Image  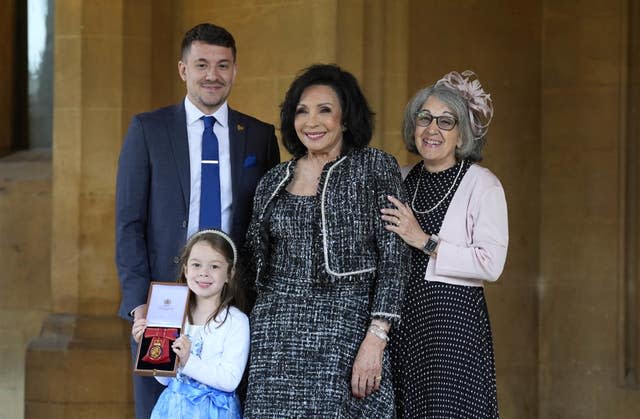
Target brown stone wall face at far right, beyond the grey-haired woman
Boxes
[539,0,640,419]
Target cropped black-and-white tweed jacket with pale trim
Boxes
[244,147,410,322]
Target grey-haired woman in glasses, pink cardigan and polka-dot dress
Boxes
[382,71,508,418]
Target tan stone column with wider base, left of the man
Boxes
[25,0,169,419]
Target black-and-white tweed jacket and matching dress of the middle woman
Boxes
[244,148,409,418]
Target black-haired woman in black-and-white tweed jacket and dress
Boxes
[245,65,408,418]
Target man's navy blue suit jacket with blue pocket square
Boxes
[116,103,280,319]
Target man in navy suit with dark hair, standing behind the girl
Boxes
[116,23,280,419]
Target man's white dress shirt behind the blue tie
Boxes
[184,97,233,238]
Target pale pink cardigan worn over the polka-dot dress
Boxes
[425,164,509,287]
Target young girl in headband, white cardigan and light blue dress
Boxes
[133,230,249,419]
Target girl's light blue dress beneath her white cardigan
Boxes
[151,325,242,419]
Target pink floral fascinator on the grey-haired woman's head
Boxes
[435,70,493,140]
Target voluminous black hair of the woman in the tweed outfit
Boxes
[280,64,374,157]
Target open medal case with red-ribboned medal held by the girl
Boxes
[133,281,189,377]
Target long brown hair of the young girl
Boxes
[177,230,245,327]
